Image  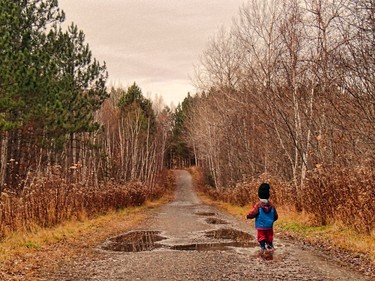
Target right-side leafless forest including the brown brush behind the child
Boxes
[181,0,375,233]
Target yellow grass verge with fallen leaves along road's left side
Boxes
[0,187,173,280]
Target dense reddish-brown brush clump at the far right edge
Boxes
[302,167,375,233]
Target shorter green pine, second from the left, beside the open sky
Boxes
[49,23,108,134]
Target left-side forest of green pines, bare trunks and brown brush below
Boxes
[0,0,172,237]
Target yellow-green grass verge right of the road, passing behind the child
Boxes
[198,192,375,266]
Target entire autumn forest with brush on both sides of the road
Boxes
[0,0,375,241]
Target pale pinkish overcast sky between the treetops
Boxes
[59,0,244,105]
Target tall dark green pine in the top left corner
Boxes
[0,0,64,131]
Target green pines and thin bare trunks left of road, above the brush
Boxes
[0,0,172,192]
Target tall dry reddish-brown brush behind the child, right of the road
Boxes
[192,167,375,234]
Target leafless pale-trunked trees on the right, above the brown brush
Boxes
[189,0,374,188]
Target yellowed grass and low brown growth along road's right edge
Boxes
[190,166,375,266]
